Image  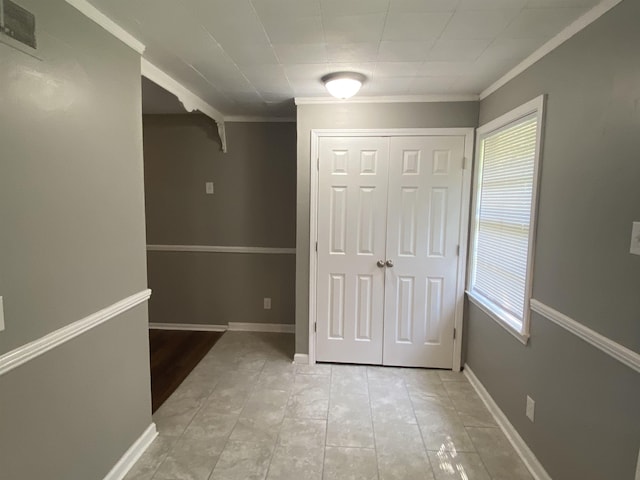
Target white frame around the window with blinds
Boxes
[466,95,546,345]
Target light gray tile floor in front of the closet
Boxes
[126,332,532,480]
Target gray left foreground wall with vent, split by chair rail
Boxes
[0,0,151,480]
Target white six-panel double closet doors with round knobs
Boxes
[316,136,465,368]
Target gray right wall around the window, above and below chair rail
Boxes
[466,0,640,480]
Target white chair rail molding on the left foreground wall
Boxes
[0,289,151,375]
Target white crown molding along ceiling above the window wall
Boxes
[480,0,622,100]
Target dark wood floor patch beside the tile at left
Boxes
[149,330,222,412]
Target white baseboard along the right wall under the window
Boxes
[463,365,551,480]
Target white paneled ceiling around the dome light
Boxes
[90,0,598,116]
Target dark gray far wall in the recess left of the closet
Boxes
[144,115,296,324]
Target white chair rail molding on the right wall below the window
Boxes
[529,298,640,372]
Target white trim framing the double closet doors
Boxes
[309,128,474,371]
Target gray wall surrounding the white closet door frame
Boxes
[296,102,478,353]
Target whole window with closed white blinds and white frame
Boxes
[467,96,544,343]
